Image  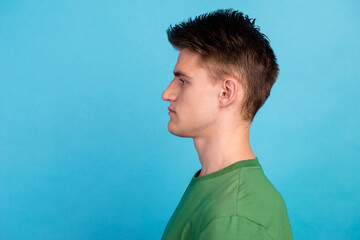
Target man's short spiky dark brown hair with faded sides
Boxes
[167,9,279,121]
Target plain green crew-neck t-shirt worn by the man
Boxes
[161,158,293,240]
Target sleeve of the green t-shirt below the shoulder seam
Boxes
[196,216,273,240]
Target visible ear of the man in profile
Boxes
[219,77,241,106]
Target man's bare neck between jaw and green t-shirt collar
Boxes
[193,120,256,176]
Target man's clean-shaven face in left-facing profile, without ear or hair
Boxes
[162,49,220,137]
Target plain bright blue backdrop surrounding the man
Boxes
[0,0,360,239]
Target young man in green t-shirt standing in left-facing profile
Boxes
[162,9,292,240]
